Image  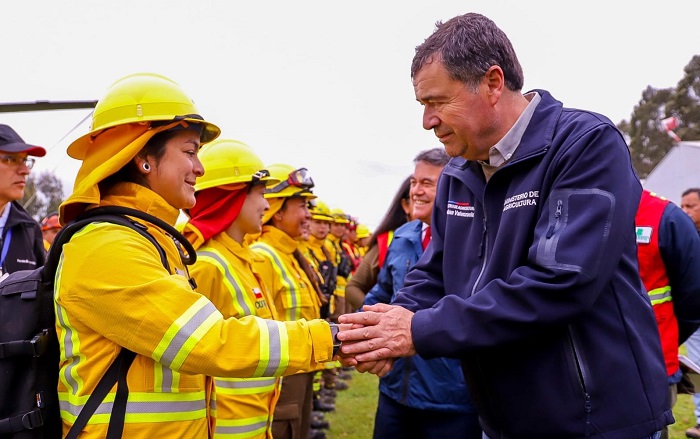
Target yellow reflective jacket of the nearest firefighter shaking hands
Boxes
[54,183,333,439]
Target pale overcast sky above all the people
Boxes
[0,0,700,227]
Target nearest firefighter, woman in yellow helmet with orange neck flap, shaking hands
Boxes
[54,74,334,438]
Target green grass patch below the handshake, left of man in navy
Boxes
[325,371,379,439]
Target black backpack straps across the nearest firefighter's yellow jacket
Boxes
[57,211,176,439]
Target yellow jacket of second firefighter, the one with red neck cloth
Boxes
[190,232,280,439]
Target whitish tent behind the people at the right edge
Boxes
[642,141,700,206]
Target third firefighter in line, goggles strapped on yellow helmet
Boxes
[251,164,327,439]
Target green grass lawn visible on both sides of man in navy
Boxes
[326,372,695,439]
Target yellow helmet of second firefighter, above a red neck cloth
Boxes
[194,138,279,191]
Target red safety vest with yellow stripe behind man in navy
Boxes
[634,190,679,376]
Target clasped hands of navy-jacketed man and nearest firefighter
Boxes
[338,303,416,376]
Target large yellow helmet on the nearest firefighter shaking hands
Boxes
[68,73,221,160]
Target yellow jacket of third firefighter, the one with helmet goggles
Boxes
[250,226,321,320]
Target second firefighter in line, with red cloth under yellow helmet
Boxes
[184,139,280,439]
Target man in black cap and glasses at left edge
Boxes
[0,125,46,274]
